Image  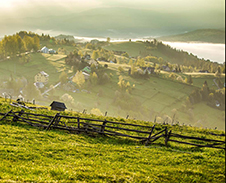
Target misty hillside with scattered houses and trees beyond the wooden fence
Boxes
[0,31,225,130]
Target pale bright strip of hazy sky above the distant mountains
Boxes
[0,0,225,15]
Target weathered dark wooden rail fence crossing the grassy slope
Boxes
[0,110,225,150]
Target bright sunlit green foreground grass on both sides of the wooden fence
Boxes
[0,98,225,183]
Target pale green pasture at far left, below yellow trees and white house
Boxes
[0,53,67,84]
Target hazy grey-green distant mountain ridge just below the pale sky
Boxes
[0,8,224,38]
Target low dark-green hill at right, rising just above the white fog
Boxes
[158,29,225,44]
